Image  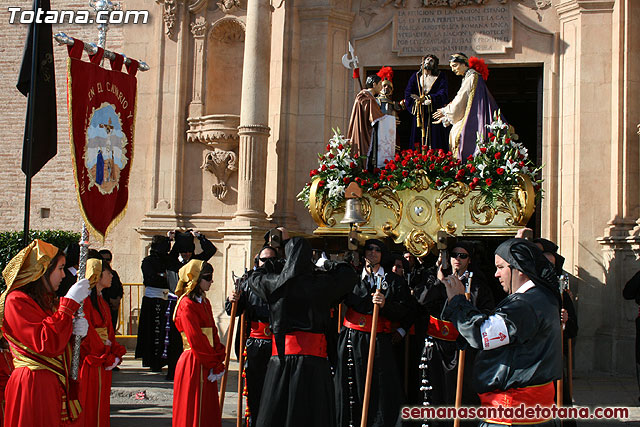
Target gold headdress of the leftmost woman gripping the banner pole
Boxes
[0,239,58,327]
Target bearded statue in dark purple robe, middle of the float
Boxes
[401,55,449,151]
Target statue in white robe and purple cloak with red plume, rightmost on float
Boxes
[433,53,498,160]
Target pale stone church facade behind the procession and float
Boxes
[0,0,640,373]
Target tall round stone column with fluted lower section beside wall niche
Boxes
[233,0,271,225]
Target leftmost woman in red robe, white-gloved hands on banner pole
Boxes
[0,240,89,427]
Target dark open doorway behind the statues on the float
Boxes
[367,64,543,236]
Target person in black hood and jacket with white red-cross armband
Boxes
[443,239,562,426]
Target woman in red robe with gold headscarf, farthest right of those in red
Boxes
[173,260,225,427]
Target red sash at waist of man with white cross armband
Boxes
[478,382,555,424]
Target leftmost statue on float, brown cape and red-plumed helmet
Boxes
[347,67,396,171]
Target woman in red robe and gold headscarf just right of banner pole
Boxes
[72,259,127,427]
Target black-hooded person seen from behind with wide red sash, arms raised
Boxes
[249,237,358,427]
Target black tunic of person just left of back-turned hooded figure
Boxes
[224,271,271,427]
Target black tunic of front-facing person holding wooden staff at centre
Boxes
[335,272,411,427]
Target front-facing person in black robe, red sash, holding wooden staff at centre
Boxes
[334,239,413,427]
